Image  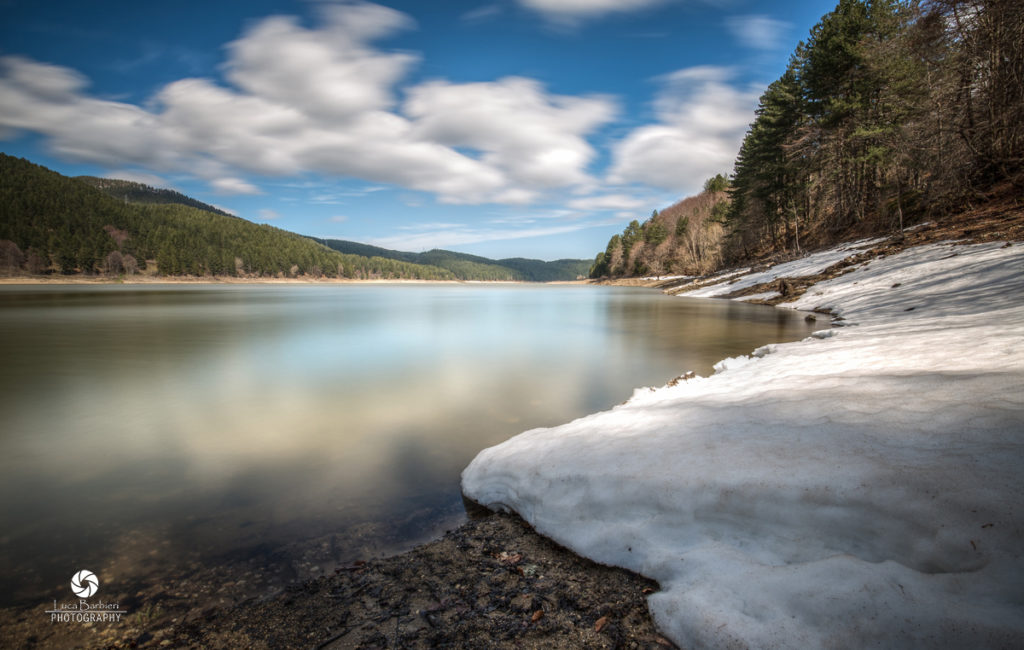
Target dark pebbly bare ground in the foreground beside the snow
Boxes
[0,210,1019,648]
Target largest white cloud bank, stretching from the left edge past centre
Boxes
[0,3,615,204]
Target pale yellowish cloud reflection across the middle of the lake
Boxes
[4,335,584,507]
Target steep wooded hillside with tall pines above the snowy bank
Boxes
[592,0,1024,277]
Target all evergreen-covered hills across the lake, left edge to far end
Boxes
[0,154,590,281]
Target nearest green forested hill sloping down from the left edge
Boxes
[0,154,455,279]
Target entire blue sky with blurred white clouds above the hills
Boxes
[0,0,835,259]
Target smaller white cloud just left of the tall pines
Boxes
[608,66,758,193]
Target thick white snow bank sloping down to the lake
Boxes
[463,243,1024,648]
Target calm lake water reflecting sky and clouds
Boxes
[0,285,824,605]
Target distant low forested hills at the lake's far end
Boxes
[316,240,591,283]
